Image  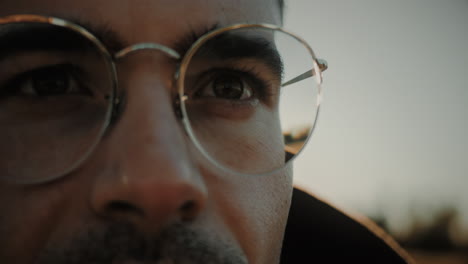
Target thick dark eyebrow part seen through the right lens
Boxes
[188,33,283,80]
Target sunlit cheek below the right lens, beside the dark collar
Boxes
[211,166,292,263]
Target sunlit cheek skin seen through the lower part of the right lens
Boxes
[188,105,285,174]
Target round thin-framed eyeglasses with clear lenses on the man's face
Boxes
[0,15,327,184]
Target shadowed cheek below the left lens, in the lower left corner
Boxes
[0,175,92,263]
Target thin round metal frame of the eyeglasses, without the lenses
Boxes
[0,14,328,184]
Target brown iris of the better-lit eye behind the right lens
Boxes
[213,76,244,99]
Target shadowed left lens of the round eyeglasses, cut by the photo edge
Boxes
[0,22,113,183]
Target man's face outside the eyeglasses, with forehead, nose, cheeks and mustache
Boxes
[0,0,292,264]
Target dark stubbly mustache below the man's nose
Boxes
[35,223,248,264]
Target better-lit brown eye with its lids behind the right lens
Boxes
[184,63,280,119]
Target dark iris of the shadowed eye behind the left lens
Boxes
[32,69,70,96]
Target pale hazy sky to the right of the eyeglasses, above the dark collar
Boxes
[285,0,468,239]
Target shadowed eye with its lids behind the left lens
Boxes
[0,58,106,121]
